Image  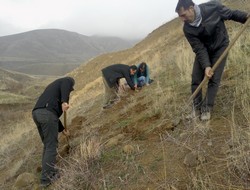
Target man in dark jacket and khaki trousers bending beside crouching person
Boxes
[102,64,137,109]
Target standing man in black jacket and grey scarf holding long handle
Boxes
[175,0,249,120]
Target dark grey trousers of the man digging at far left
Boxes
[32,108,59,184]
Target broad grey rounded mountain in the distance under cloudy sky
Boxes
[0,29,139,75]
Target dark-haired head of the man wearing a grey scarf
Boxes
[175,0,195,23]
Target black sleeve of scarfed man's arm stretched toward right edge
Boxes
[218,3,247,23]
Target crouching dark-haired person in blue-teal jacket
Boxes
[134,62,150,87]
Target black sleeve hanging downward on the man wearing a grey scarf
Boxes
[184,30,211,69]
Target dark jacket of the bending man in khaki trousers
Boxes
[102,64,135,90]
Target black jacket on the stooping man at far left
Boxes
[33,77,75,117]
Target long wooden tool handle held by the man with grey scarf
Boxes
[188,18,250,104]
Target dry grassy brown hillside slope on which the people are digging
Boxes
[0,1,250,190]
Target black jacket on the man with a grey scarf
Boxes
[183,1,247,69]
